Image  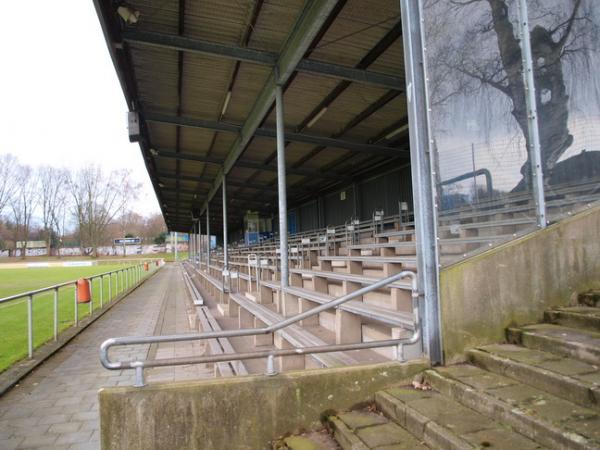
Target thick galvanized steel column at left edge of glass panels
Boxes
[400,0,443,364]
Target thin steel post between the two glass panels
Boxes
[518,0,546,228]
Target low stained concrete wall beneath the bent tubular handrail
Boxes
[99,361,427,450]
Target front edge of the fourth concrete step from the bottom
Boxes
[467,349,600,409]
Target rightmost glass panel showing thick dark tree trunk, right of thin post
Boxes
[528,0,600,220]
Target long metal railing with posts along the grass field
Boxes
[0,263,161,358]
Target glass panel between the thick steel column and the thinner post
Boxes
[423,0,536,263]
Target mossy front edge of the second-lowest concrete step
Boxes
[375,391,476,450]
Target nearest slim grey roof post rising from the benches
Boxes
[275,84,289,298]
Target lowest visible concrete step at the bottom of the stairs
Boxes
[328,410,429,450]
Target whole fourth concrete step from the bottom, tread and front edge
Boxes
[467,344,600,410]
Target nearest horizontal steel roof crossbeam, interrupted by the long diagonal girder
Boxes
[121,29,404,90]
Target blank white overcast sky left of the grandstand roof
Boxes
[0,0,160,214]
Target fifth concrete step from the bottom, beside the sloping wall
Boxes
[507,323,600,365]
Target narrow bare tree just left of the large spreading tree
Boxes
[38,166,68,255]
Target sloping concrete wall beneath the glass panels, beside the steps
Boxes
[440,207,600,363]
